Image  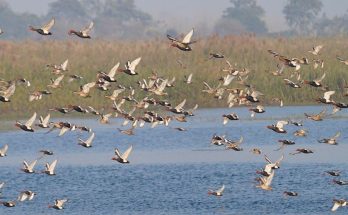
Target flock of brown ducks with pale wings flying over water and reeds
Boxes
[0,19,348,211]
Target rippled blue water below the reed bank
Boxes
[0,107,348,215]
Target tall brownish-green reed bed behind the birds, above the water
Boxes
[0,35,348,119]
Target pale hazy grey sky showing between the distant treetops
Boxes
[5,0,348,31]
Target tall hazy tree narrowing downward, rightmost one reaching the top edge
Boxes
[283,0,323,35]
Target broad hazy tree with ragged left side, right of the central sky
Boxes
[218,0,268,34]
